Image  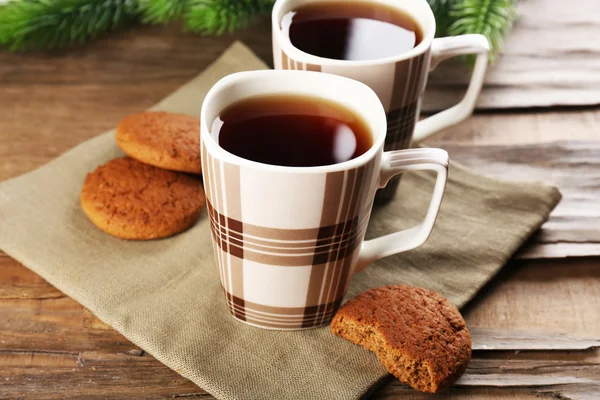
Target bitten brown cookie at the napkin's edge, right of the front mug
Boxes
[331,285,471,393]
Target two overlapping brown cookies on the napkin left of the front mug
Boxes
[80,112,204,240]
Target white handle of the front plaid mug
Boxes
[356,148,448,271]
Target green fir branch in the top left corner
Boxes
[0,0,136,50]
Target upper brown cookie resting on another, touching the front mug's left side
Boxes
[115,112,202,174]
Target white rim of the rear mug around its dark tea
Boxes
[271,0,436,66]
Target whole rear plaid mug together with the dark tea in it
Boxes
[271,0,489,204]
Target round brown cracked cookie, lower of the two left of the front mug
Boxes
[80,157,204,240]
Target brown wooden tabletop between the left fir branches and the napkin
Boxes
[0,20,271,180]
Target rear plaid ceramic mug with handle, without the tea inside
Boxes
[271,0,489,203]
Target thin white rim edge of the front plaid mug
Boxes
[200,70,387,174]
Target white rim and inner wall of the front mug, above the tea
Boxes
[200,70,387,173]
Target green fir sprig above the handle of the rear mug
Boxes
[447,0,516,61]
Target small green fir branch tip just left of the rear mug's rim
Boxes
[183,0,274,35]
